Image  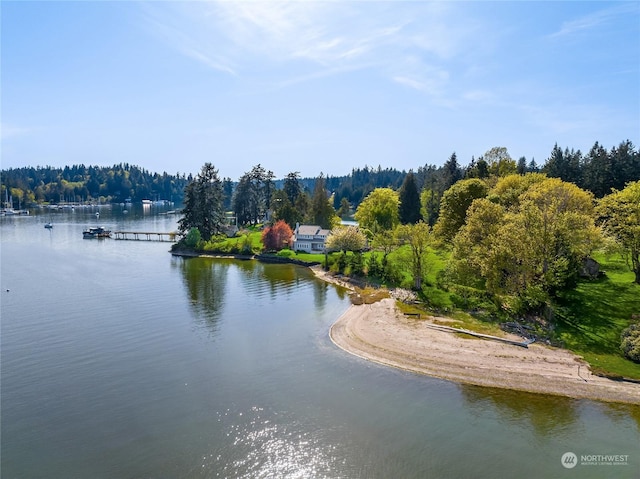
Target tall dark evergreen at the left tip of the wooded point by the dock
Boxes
[178,163,225,241]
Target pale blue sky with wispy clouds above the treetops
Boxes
[0,0,640,179]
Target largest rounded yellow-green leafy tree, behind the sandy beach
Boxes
[452,178,600,306]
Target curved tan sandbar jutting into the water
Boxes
[329,298,640,404]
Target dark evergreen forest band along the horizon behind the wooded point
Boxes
[0,140,640,214]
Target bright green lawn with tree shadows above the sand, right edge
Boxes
[556,255,640,379]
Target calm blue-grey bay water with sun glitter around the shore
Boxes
[0,207,640,479]
